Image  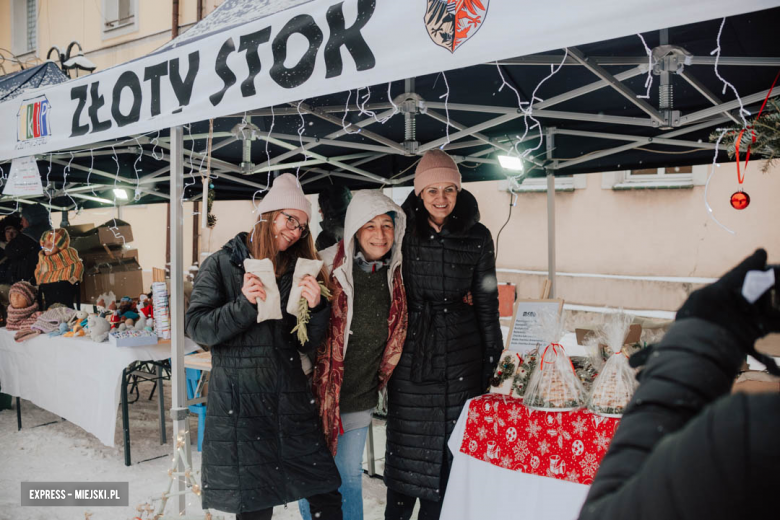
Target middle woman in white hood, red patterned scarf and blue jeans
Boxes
[299,190,407,520]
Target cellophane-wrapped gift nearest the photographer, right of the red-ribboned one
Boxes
[587,312,639,417]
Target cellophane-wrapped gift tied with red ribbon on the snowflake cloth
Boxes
[523,311,585,411]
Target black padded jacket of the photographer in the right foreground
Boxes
[580,318,780,520]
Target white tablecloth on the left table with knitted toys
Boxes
[0,329,198,446]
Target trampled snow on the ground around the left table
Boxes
[0,381,408,520]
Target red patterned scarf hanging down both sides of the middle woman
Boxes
[312,240,408,456]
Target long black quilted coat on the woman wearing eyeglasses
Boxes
[185,233,341,513]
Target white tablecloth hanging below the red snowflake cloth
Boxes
[441,400,590,520]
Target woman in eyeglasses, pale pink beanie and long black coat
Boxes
[185,173,342,520]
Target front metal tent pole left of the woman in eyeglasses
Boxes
[169,126,192,514]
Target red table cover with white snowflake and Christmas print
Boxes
[460,394,620,484]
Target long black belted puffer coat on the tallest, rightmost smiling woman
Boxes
[385,190,503,501]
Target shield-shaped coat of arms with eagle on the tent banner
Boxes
[425,0,489,52]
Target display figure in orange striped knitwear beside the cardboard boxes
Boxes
[35,228,84,309]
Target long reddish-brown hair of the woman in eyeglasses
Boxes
[246,211,328,285]
